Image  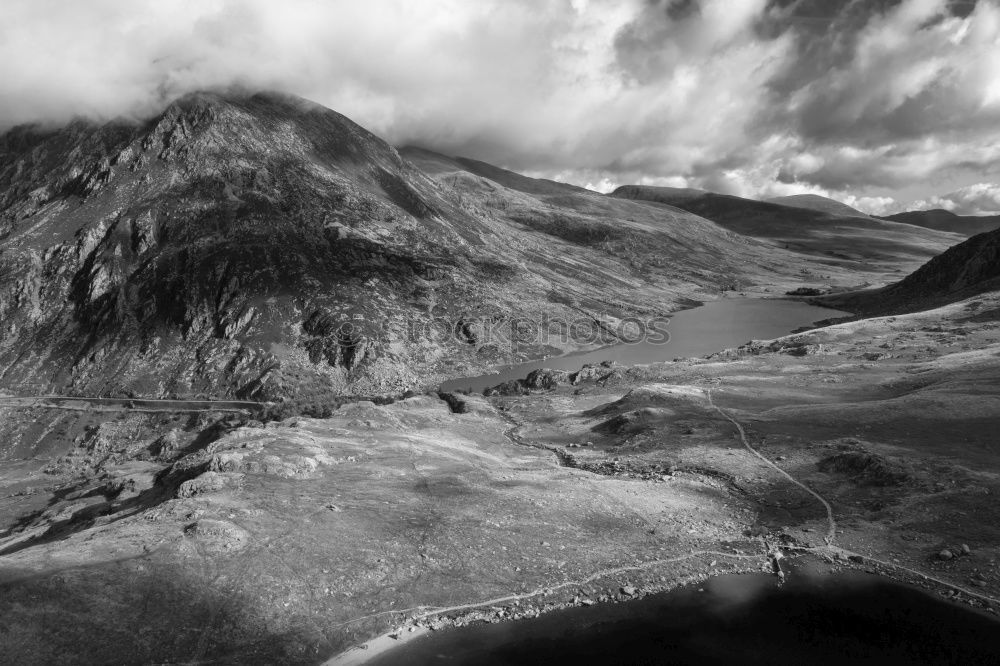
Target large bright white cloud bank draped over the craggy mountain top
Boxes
[0,0,791,175]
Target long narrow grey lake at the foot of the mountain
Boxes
[440,298,849,392]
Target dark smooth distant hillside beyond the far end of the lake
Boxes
[611,185,962,275]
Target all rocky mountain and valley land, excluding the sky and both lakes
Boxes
[0,94,1000,664]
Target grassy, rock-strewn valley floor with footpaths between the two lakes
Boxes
[0,294,1000,663]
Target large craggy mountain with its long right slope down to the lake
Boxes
[0,94,796,398]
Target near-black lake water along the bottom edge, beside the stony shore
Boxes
[370,573,1000,666]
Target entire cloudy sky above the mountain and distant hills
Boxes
[0,0,1000,214]
